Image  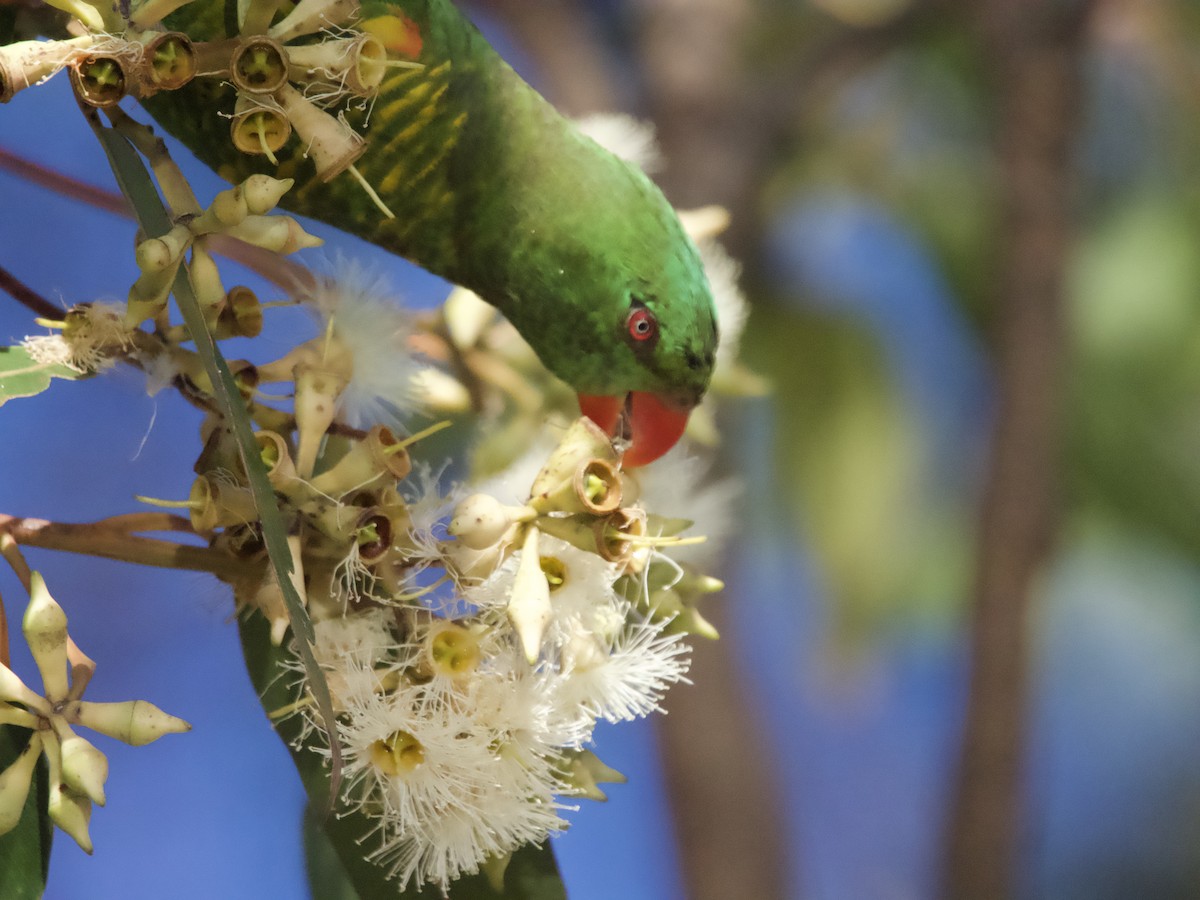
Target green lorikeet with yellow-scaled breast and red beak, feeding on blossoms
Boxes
[143,0,716,466]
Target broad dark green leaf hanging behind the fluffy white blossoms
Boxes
[239,611,566,900]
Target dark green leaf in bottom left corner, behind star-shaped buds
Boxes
[0,725,54,900]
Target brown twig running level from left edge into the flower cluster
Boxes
[0,514,246,581]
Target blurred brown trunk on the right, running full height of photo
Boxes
[943,0,1090,900]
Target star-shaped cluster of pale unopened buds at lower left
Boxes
[0,572,191,853]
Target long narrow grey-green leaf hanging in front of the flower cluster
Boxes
[89,116,342,808]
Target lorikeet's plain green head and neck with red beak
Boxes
[468,137,716,466]
